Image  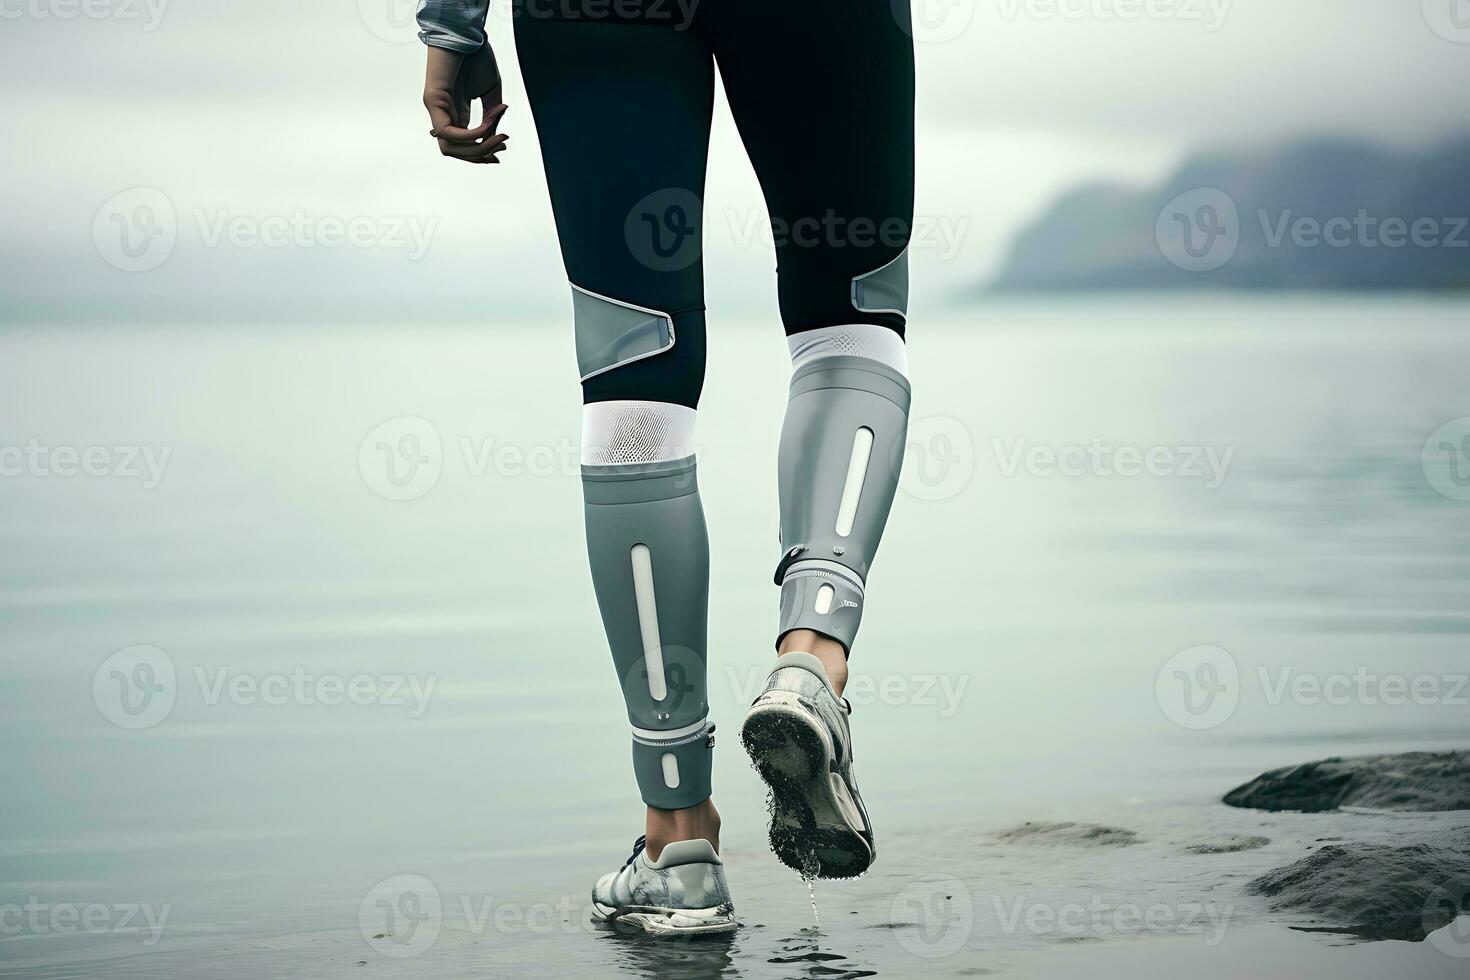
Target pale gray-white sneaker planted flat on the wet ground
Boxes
[592,837,739,936]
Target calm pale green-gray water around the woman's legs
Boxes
[0,297,1470,977]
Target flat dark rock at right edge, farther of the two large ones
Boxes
[1225,752,1470,813]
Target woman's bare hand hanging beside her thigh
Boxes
[423,44,510,163]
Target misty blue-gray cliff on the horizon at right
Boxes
[991,137,1470,291]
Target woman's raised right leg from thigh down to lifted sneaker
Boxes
[700,0,914,877]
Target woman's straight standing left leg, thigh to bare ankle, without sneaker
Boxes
[516,13,719,860]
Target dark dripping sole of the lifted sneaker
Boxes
[741,692,873,879]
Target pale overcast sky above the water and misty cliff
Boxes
[0,0,1470,319]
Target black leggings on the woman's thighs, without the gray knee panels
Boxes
[516,0,914,408]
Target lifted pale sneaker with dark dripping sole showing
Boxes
[741,652,878,879]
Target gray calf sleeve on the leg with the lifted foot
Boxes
[776,356,910,649]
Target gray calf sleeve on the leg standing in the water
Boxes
[582,457,714,810]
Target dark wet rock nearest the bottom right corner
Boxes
[1248,835,1470,942]
